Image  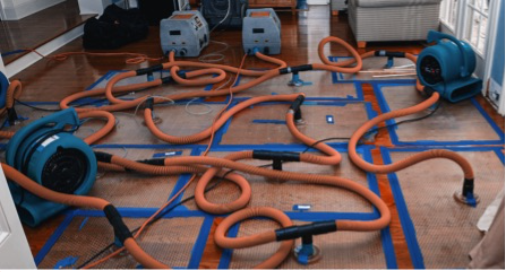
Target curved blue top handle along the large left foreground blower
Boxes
[7,108,79,163]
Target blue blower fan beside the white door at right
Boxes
[417,30,482,103]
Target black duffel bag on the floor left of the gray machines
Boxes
[83,5,149,49]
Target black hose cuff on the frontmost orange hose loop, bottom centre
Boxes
[275,220,337,241]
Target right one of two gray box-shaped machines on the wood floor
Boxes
[242,8,281,55]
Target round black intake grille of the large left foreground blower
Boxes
[41,148,88,194]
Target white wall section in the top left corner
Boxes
[0,0,65,20]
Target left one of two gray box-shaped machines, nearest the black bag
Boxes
[160,10,209,57]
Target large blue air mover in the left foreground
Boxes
[6,108,97,226]
